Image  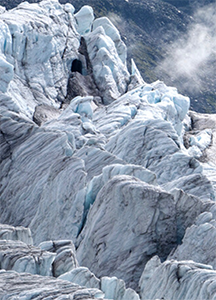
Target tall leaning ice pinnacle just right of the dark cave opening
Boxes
[85,26,129,104]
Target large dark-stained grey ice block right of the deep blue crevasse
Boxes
[77,175,176,288]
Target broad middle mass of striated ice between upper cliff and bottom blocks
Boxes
[0,68,214,288]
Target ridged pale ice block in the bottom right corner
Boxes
[140,260,216,300]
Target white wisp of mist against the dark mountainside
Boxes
[156,4,216,93]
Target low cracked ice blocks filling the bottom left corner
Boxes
[0,224,140,300]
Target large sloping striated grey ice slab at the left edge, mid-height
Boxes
[1,113,86,242]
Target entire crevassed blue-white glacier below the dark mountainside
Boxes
[0,0,216,300]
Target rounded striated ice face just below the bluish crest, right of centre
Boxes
[106,118,179,168]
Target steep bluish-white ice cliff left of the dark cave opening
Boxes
[0,1,79,117]
